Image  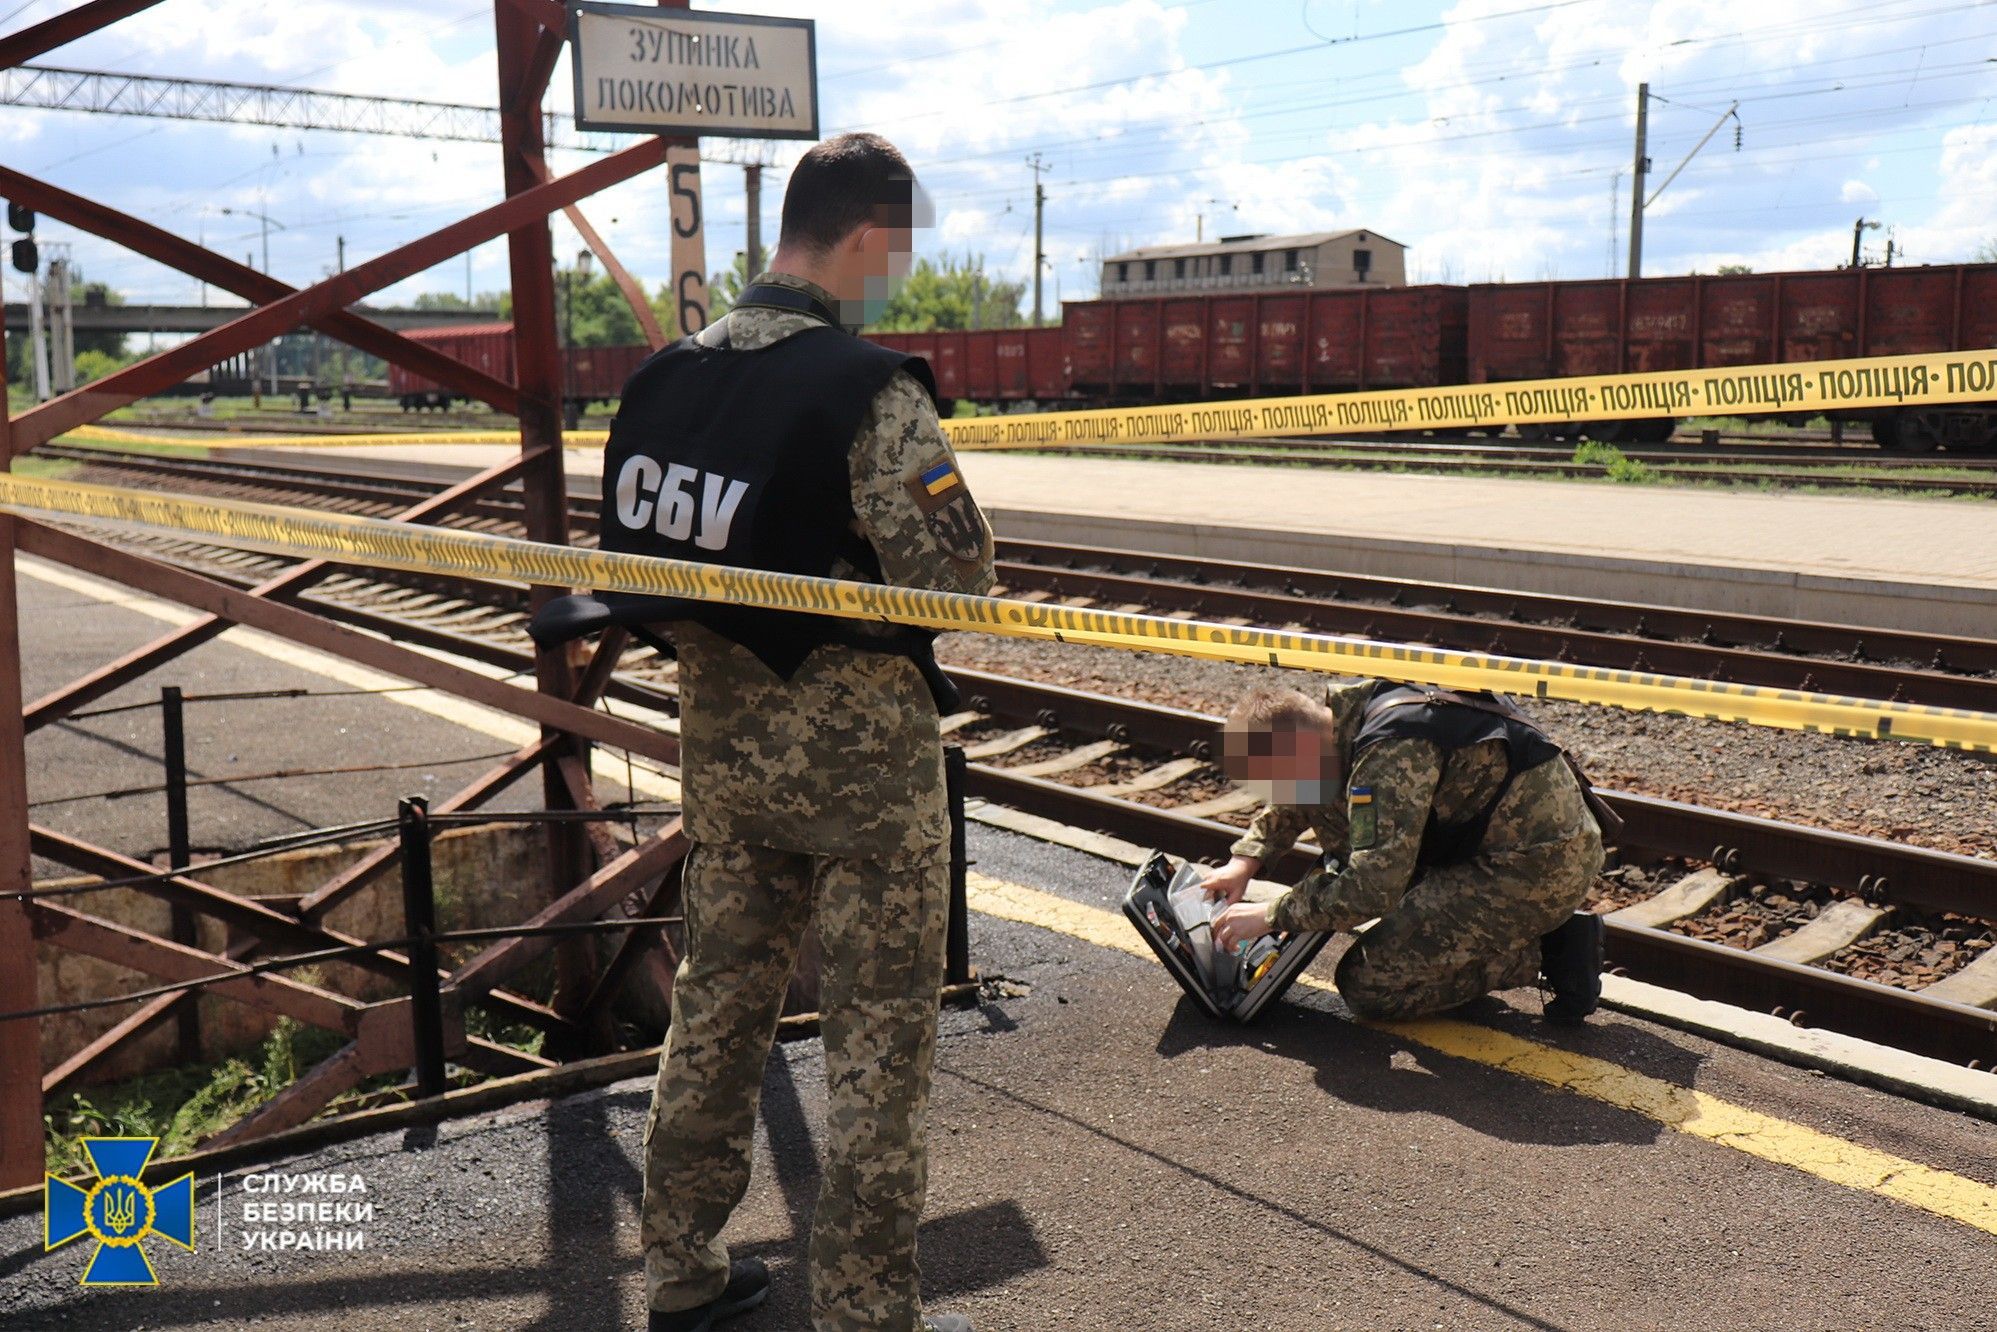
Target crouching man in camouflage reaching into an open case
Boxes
[1206,681,1602,1024]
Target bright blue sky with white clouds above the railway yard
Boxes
[0,0,1997,319]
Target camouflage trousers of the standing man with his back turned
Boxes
[641,843,951,1332]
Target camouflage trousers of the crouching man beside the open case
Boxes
[1338,821,1602,1020]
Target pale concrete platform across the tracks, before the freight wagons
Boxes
[216,445,1997,637]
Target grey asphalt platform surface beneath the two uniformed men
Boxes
[0,555,1997,1332]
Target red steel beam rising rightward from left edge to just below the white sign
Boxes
[12,140,665,453]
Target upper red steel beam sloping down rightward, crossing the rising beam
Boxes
[0,166,519,415]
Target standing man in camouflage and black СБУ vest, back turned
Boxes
[603,134,993,1332]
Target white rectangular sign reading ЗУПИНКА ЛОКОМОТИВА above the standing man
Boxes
[569,0,819,138]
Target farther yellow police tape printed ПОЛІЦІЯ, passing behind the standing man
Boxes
[72,349,1997,449]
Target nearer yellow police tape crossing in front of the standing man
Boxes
[0,473,1997,753]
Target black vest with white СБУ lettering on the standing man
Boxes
[601,309,935,679]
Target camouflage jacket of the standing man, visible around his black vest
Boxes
[673,274,993,861]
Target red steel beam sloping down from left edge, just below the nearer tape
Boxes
[18,519,677,763]
